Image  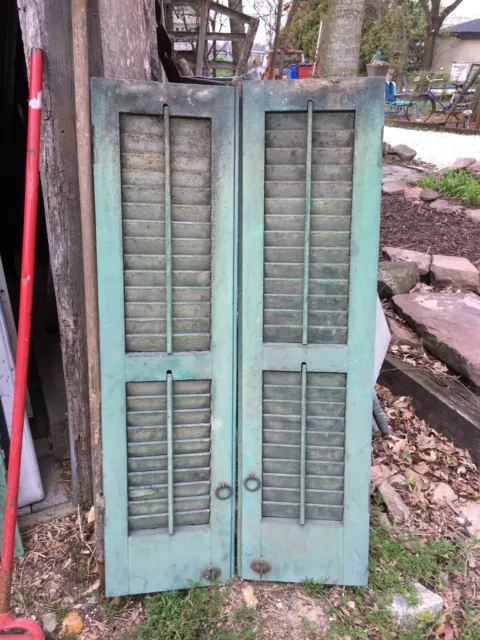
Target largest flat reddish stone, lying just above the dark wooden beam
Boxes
[393,292,480,386]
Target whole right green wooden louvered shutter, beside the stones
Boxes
[238,79,383,585]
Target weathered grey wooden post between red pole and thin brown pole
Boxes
[17,0,92,507]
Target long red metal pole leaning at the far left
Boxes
[0,49,44,640]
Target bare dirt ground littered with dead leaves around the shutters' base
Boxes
[12,376,480,640]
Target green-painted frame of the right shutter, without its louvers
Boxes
[238,78,384,585]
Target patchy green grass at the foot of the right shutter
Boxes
[304,517,480,640]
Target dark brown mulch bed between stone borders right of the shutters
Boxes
[380,196,480,262]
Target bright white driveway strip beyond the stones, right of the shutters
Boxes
[384,127,480,167]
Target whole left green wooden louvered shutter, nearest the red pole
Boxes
[92,79,236,595]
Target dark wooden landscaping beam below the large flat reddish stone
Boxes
[378,354,480,464]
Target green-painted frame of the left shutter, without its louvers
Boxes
[91,78,236,596]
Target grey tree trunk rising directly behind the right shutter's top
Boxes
[315,0,365,77]
